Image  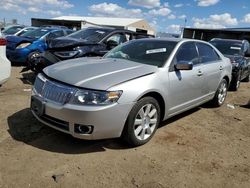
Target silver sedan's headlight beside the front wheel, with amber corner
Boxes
[71,90,122,105]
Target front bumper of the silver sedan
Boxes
[31,95,134,140]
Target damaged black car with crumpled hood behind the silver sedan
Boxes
[30,27,153,71]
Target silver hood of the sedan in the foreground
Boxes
[43,58,158,90]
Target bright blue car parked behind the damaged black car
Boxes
[6,27,73,66]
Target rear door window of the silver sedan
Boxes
[196,43,220,63]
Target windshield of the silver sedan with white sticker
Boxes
[104,40,177,67]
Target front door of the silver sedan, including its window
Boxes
[168,42,204,115]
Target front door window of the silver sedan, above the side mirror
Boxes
[174,42,199,65]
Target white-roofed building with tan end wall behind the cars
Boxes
[31,16,155,35]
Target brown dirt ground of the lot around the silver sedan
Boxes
[0,67,250,188]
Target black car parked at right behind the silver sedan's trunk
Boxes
[210,38,250,91]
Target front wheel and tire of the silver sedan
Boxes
[122,97,161,147]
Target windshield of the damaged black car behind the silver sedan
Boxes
[68,29,107,42]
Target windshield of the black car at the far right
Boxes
[210,41,242,55]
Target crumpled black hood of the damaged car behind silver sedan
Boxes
[49,37,96,49]
